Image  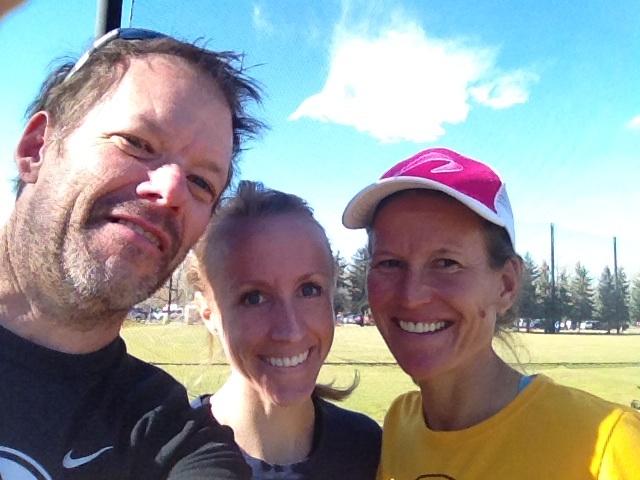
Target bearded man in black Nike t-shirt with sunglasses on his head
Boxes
[0,29,260,480]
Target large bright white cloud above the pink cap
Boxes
[289,18,538,142]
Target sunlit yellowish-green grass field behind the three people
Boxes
[123,324,640,421]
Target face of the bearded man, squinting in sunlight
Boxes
[18,55,232,320]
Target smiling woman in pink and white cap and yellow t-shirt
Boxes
[343,148,640,480]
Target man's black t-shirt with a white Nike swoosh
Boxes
[0,327,250,480]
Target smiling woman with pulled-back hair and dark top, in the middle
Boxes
[191,181,381,480]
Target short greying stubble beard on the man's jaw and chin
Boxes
[21,191,184,331]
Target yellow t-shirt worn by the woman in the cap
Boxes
[378,375,640,480]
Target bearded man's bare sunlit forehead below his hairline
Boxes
[62,54,233,166]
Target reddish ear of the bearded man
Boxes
[15,112,49,183]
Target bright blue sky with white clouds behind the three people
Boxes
[0,0,640,277]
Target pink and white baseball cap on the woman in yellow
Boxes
[342,148,516,248]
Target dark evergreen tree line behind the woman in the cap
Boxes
[334,247,640,333]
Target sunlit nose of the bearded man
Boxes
[136,163,188,211]
